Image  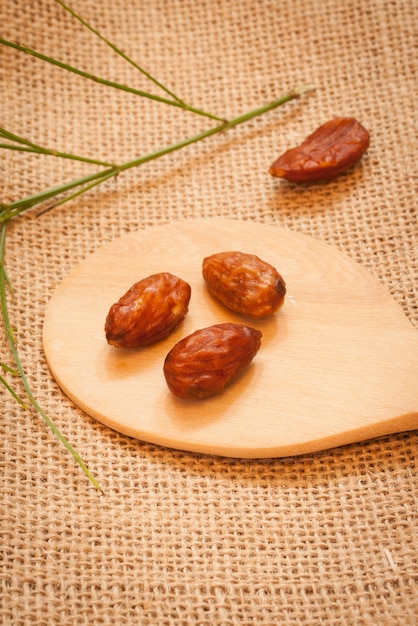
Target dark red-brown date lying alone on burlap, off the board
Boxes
[269,117,370,183]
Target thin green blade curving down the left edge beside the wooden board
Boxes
[0,224,101,491]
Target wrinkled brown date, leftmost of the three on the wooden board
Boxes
[105,272,191,348]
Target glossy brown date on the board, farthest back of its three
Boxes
[202,252,286,318]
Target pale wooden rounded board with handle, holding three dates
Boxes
[43,218,418,458]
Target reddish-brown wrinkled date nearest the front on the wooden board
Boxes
[164,323,261,400]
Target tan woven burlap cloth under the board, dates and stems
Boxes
[0,0,418,626]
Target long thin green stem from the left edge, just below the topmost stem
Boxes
[0,37,224,121]
